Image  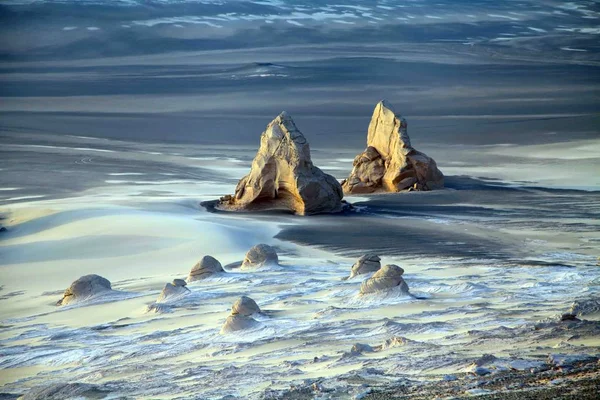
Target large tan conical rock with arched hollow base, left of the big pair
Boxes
[216,112,344,215]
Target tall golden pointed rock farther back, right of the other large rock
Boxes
[342,101,444,193]
